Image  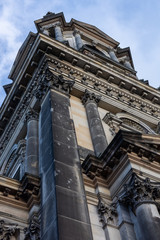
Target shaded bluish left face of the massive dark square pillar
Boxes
[39,94,58,240]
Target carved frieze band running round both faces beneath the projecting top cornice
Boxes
[0,55,160,155]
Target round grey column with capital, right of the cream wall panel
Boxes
[82,90,108,157]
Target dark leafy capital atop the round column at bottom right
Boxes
[119,173,160,210]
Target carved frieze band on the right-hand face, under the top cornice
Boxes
[48,56,160,118]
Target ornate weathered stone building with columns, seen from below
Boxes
[0,12,160,240]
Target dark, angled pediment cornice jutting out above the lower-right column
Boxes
[82,131,160,179]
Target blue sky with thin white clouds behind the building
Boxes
[0,0,160,105]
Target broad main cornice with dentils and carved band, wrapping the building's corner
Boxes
[0,34,160,155]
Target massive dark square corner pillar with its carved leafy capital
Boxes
[39,72,92,240]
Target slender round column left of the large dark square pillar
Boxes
[25,109,39,176]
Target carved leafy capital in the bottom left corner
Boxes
[0,220,19,240]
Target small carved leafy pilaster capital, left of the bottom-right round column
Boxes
[97,198,118,227]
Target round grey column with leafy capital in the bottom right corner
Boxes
[119,174,160,240]
